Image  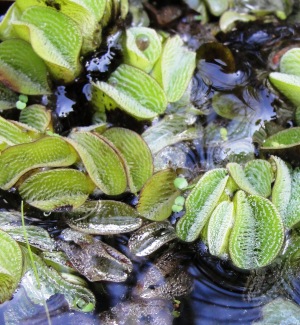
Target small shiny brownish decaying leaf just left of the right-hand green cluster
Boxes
[128,221,177,256]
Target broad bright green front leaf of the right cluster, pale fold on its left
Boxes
[229,191,284,270]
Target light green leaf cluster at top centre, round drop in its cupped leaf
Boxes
[92,31,196,119]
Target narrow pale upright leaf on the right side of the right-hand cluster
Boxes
[271,156,290,217]
